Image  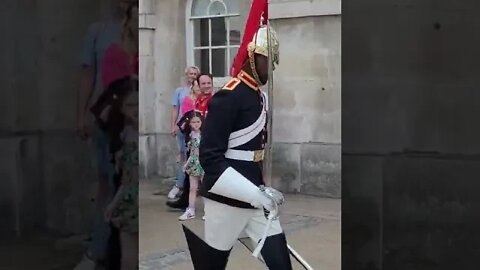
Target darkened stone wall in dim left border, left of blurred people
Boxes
[0,0,110,237]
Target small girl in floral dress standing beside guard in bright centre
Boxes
[179,112,204,220]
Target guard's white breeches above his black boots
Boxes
[204,198,283,251]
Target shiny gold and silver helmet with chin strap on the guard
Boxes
[247,25,280,85]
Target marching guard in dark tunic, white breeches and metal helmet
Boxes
[186,23,292,270]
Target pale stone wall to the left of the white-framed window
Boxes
[140,0,186,178]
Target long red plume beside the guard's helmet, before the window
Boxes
[230,0,268,77]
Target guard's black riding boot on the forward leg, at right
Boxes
[261,233,292,270]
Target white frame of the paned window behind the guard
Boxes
[185,0,240,88]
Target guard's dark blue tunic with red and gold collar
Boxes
[200,72,266,208]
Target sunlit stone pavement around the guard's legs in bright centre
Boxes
[140,179,341,270]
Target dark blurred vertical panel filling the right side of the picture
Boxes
[342,0,480,270]
